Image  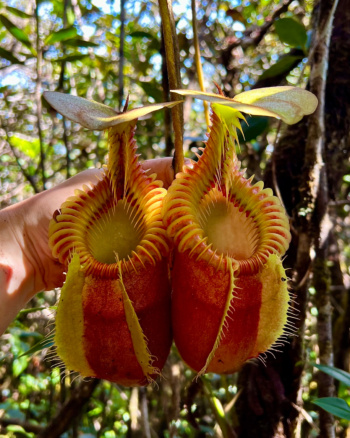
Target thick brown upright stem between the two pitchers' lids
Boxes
[158,0,184,174]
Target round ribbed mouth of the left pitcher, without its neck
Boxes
[49,172,169,278]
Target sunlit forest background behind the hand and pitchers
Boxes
[0,0,350,438]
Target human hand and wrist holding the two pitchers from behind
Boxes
[0,158,179,334]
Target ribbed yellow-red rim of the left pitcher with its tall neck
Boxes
[49,121,169,279]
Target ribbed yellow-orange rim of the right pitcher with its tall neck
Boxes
[163,104,290,276]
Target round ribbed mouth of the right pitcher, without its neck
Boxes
[164,170,290,274]
